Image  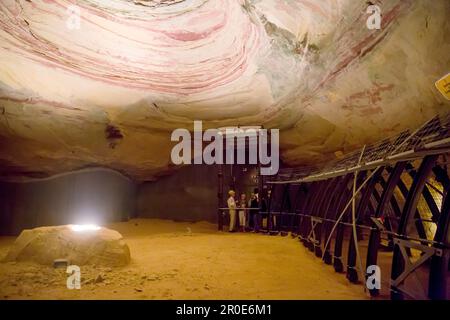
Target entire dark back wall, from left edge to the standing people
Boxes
[0,165,253,235]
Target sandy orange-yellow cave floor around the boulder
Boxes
[0,219,367,299]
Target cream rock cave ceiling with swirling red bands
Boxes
[0,0,450,180]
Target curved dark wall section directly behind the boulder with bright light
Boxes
[0,169,136,235]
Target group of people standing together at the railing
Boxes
[227,190,264,232]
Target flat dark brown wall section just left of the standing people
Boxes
[137,165,217,222]
